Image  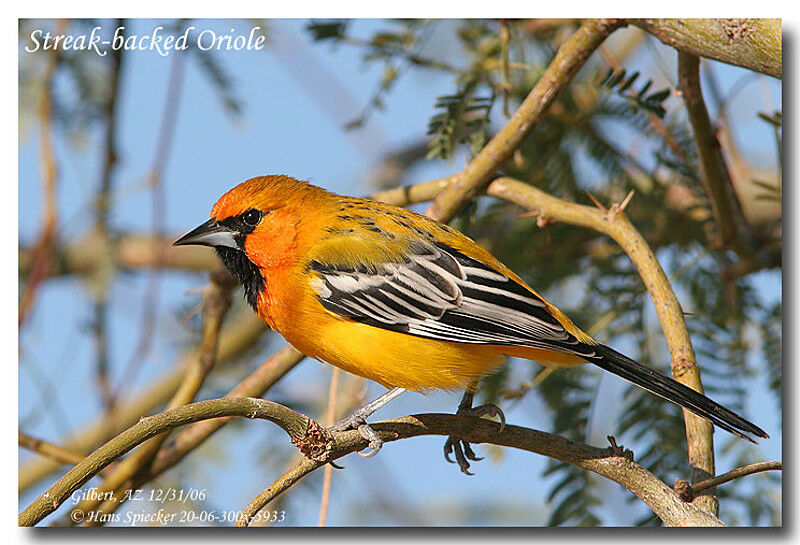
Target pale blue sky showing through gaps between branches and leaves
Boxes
[19,20,781,525]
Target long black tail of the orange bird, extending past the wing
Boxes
[586,344,769,443]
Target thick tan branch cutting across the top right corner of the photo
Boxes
[628,19,783,78]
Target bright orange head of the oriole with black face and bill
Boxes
[174,176,331,308]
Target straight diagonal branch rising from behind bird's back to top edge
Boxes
[428,19,622,221]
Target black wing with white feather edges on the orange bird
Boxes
[309,243,585,354]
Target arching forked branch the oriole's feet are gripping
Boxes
[19,398,722,526]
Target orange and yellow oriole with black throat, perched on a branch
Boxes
[174,175,769,474]
